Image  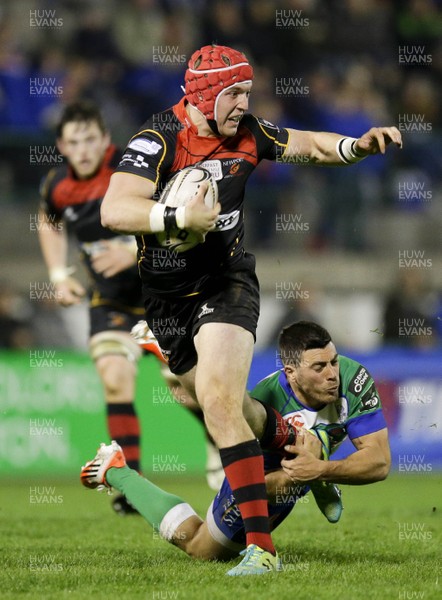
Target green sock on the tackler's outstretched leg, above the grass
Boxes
[106,466,184,531]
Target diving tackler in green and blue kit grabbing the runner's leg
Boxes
[81,321,391,575]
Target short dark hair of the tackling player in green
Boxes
[279,321,331,366]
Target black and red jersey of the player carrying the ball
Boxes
[117,99,288,297]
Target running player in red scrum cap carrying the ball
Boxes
[101,45,402,574]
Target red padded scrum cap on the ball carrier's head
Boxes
[184,46,253,122]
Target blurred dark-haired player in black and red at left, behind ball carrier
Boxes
[39,101,222,514]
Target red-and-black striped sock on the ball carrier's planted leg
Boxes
[220,440,276,554]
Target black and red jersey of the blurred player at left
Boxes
[41,145,142,307]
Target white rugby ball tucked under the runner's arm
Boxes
[156,167,218,252]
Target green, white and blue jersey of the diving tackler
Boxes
[250,356,387,453]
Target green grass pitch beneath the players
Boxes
[0,475,442,600]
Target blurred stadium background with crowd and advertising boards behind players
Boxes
[0,0,442,483]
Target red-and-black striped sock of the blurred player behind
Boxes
[106,402,140,472]
